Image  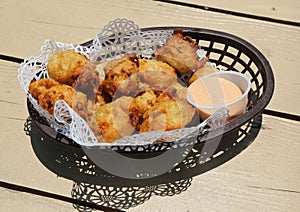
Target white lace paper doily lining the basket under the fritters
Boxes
[18,19,227,147]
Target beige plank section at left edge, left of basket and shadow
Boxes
[0,61,72,195]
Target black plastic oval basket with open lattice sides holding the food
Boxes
[28,27,274,153]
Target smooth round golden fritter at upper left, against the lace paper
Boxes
[47,50,89,85]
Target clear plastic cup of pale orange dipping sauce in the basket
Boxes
[186,71,251,120]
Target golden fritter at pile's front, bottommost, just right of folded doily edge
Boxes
[95,96,135,143]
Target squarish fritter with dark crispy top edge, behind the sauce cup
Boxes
[155,30,208,74]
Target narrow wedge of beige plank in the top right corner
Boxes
[169,0,300,22]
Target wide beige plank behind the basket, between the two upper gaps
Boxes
[0,0,300,114]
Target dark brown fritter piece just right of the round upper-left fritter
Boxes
[73,63,100,101]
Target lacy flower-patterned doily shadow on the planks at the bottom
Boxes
[71,178,192,211]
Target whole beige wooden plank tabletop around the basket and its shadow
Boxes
[0,0,300,211]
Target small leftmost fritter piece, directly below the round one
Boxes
[28,78,59,99]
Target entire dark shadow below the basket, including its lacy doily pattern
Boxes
[24,112,262,211]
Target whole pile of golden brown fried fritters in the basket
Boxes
[29,30,208,142]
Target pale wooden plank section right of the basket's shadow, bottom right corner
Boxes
[132,116,300,211]
